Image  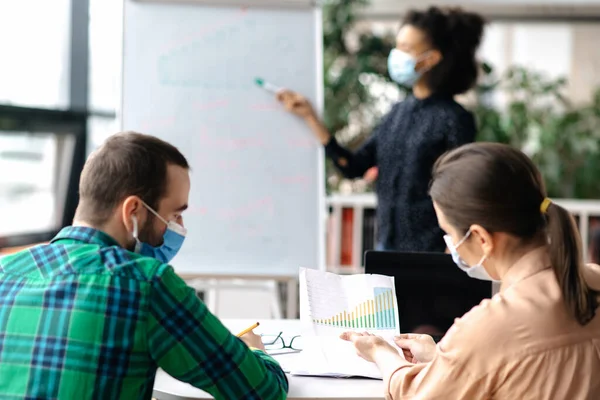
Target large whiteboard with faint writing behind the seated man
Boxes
[121,0,325,276]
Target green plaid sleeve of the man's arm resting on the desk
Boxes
[147,265,288,399]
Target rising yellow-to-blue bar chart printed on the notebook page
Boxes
[313,288,396,329]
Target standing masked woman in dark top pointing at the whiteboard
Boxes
[278,7,484,251]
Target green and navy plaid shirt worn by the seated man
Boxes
[0,227,288,400]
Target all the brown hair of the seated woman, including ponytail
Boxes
[430,143,598,325]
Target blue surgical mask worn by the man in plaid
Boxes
[131,202,187,264]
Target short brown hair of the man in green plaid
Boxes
[75,132,189,226]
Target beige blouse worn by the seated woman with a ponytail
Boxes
[386,248,600,400]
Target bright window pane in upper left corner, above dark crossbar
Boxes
[0,0,71,108]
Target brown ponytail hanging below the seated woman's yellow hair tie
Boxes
[547,204,598,325]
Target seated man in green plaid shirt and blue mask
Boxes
[0,133,288,400]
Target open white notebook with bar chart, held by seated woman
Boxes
[289,268,402,379]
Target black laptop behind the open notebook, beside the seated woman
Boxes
[365,251,492,341]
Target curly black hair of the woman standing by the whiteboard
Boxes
[402,7,485,96]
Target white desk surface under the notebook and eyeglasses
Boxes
[153,320,384,400]
